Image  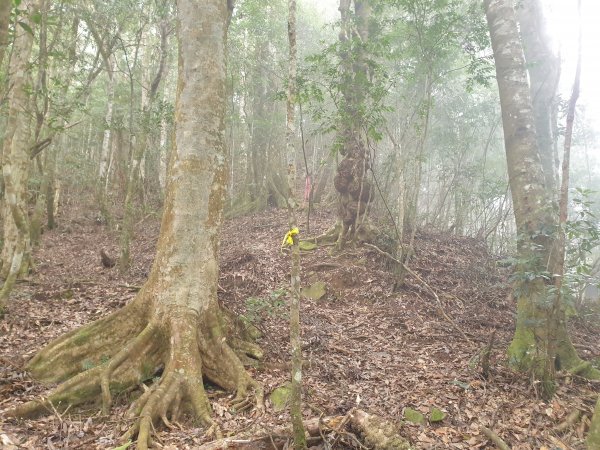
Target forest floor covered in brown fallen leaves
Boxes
[0,202,600,449]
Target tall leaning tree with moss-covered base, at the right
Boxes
[485,0,600,395]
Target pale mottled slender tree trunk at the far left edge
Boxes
[0,0,37,313]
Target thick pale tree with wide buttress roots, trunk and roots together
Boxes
[10,0,262,449]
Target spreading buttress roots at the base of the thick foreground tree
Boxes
[7,293,263,449]
